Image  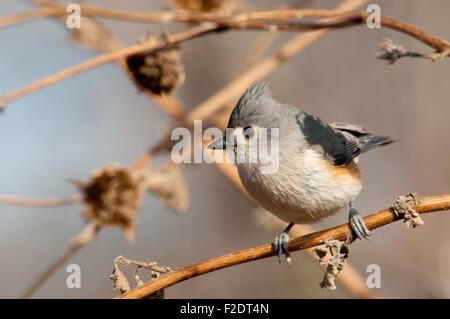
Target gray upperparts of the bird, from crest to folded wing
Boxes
[228,83,360,166]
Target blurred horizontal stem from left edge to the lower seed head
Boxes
[0,195,82,207]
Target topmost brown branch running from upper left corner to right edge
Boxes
[4,4,449,52]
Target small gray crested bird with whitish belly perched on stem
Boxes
[207,82,395,263]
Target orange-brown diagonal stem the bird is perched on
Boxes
[117,194,450,299]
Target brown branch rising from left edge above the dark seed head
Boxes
[0,3,450,110]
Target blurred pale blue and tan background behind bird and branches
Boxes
[0,0,450,298]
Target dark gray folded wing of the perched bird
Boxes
[296,112,361,166]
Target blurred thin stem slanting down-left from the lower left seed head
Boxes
[22,224,100,298]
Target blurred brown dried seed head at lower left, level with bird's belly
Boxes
[80,164,145,240]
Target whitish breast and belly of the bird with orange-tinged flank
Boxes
[237,149,362,224]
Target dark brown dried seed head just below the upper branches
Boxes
[126,47,185,95]
